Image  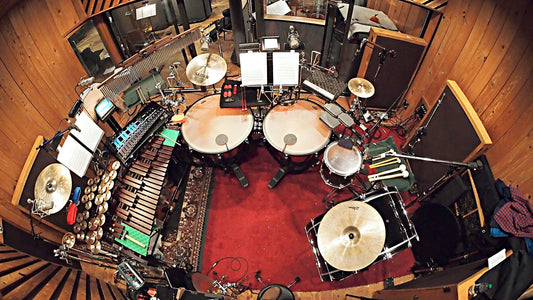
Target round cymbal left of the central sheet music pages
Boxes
[185,53,228,86]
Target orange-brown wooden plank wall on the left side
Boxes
[0,0,85,248]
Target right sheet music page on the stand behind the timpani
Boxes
[272,51,300,86]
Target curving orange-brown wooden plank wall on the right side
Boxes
[402,0,533,196]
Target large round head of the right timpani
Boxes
[263,100,331,155]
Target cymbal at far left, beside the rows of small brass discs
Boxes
[34,163,72,214]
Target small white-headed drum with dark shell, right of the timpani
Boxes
[320,142,363,189]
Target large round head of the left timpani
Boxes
[181,95,254,154]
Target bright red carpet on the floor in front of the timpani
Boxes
[198,135,414,291]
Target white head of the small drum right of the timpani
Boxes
[324,142,363,176]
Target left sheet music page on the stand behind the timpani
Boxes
[239,52,268,86]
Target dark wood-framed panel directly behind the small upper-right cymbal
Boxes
[357,27,427,110]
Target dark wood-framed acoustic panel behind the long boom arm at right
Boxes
[403,80,492,192]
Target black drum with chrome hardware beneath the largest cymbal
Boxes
[305,189,418,281]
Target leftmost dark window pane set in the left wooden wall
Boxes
[68,20,115,81]
